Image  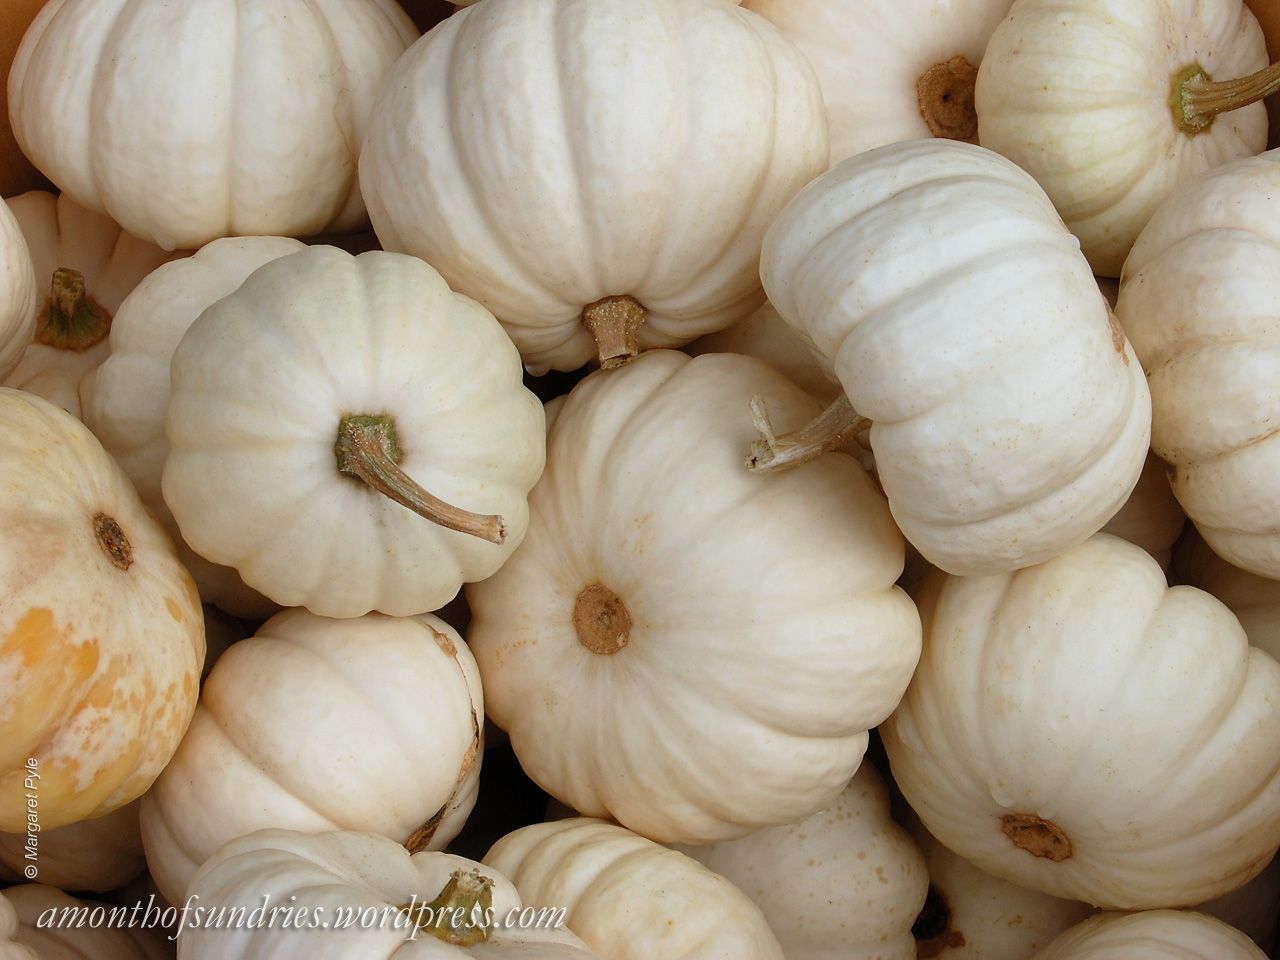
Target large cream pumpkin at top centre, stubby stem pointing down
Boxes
[360,0,827,370]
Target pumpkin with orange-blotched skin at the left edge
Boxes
[0,388,205,833]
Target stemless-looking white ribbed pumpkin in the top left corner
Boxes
[9,0,417,250]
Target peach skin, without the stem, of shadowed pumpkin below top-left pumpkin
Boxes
[3,191,186,416]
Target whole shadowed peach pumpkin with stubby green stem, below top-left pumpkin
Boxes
[4,191,174,416]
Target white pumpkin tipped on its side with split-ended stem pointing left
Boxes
[751,140,1151,575]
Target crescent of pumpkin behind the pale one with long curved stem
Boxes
[81,237,306,618]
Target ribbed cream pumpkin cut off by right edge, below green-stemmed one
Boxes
[1116,150,1280,579]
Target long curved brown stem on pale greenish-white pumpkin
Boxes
[334,415,507,544]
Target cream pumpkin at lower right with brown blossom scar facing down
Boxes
[881,534,1280,909]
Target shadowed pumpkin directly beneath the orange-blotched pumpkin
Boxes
[0,800,146,891]
